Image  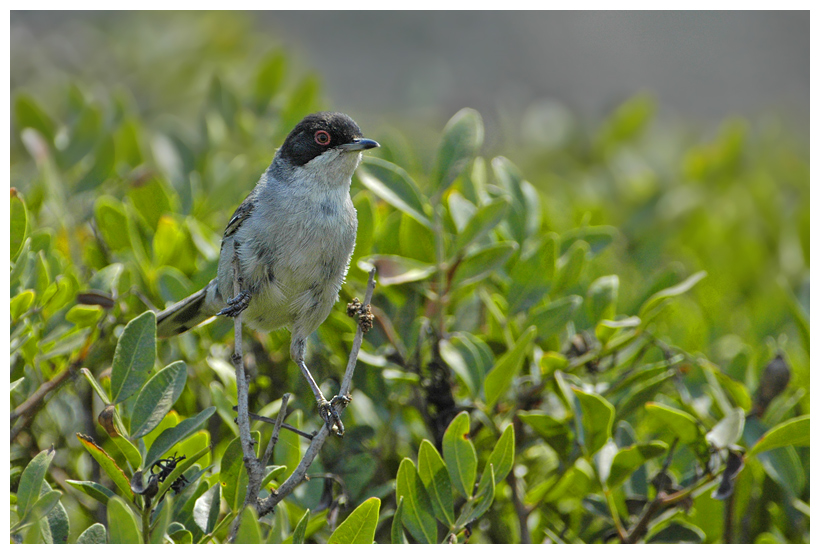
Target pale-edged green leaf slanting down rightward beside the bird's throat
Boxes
[357,157,433,229]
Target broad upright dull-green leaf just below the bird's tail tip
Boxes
[111,311,157,404]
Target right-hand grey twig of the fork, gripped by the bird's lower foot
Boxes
[257,268,376,517]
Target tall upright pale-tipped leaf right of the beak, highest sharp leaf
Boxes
[430,108,484,198]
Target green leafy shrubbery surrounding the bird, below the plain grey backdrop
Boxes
[10,14,810,543]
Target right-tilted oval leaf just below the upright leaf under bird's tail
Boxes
[131,361,188,439]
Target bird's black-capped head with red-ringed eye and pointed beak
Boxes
[278,112,379,166]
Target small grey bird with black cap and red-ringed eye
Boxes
[157,112,379,433]
